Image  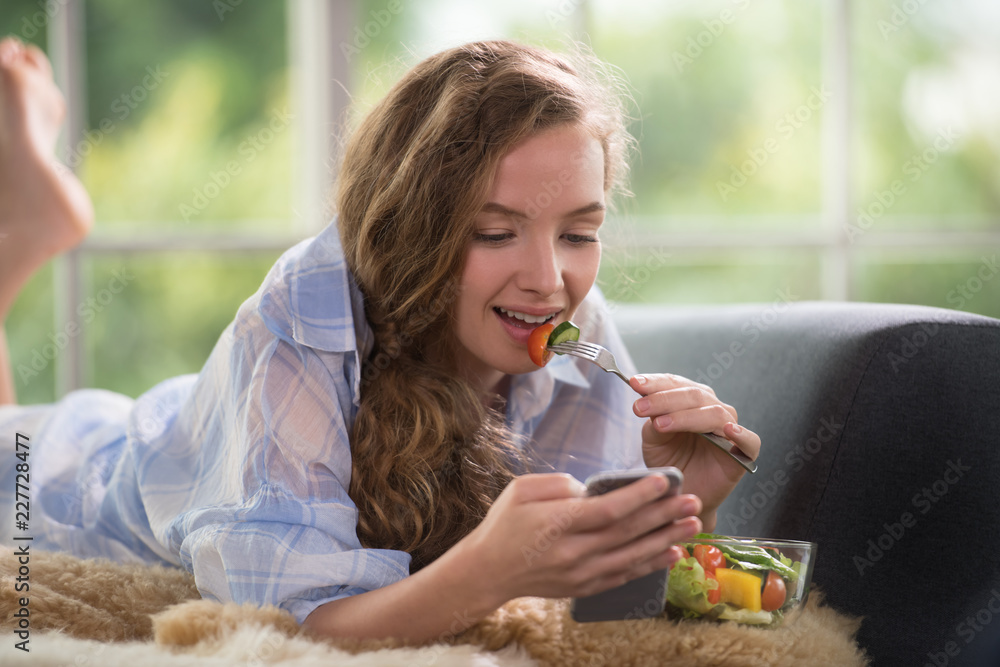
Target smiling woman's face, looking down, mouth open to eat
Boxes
[455,125,605,390]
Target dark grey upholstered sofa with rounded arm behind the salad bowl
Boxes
[614,301,1000,666]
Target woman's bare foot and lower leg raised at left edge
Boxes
[0,38,94,405]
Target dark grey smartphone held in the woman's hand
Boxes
[570,466,684,623]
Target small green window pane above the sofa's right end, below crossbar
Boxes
[856,250,1000,318]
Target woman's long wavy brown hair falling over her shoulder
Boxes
[336,41,631,571]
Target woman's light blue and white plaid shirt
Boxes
[0,224,643,622]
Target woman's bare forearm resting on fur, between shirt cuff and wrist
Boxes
[305,543,506,644]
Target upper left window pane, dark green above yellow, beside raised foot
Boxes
[82,0,293,233]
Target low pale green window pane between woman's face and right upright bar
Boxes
[598,248,821,304]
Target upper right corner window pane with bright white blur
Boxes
[852,0,1000,231]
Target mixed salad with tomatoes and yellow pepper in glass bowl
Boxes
[667,533,807,625]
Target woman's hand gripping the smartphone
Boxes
[457,473,701,606]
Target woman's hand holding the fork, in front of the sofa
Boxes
[629,374,760,531]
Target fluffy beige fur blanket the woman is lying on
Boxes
[0,547,868,667]
